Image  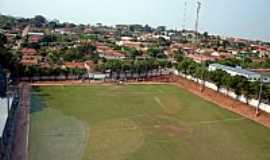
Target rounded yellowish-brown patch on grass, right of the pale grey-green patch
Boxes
[87,119,144,160]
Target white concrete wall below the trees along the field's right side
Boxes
[174,70,270,113]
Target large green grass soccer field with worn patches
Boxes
[30,85,270,160]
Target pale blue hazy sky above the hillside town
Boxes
[0,0,270,41]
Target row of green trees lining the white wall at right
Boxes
[177,58,270,103]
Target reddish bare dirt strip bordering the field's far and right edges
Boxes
[32,76,270,128]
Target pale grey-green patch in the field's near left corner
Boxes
[29,95,89,160]
